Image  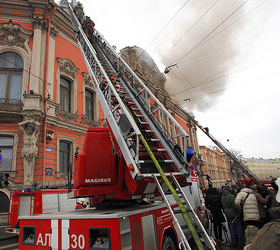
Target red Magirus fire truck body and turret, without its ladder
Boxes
[19,128,214,250]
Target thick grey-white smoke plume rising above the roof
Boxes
[151,0,252,111]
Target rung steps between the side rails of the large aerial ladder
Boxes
[89,37,187,176]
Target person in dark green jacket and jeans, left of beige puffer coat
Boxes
[221,186,243,247]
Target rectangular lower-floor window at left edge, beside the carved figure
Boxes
[0,136,14,171]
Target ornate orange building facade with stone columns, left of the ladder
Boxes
[0,0,103,207]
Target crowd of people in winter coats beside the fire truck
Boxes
[205,178,280,250]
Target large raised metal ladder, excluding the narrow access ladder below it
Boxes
[67,2,191,176]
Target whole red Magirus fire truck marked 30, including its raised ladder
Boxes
[19,2,215,250]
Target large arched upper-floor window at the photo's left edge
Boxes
[0,52,23,100]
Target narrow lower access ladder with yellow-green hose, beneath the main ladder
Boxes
[153,174,216,250]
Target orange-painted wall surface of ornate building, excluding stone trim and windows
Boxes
[0,1,104,187]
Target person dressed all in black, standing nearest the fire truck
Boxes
[205,187,225,242]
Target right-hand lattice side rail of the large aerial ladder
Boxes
[94,30,188,173]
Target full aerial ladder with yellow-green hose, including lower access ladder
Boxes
[65,1,215,249]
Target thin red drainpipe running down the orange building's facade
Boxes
[43,3,57,183]
